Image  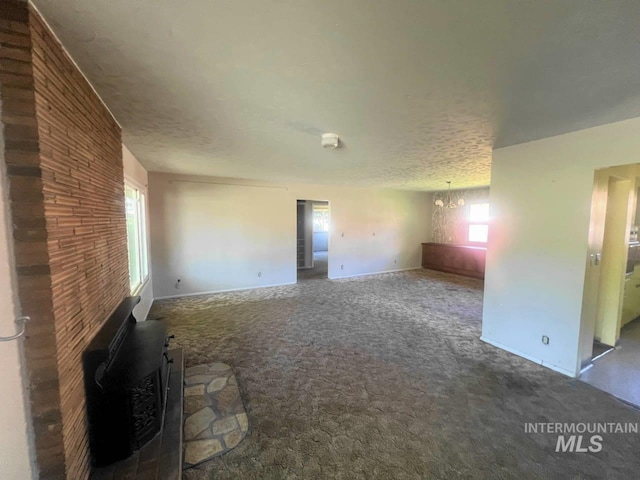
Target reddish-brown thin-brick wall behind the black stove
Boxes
[0,0,129,480]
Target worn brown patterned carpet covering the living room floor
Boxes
[151,270,640,480]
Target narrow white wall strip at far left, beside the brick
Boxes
[0,100,35,480]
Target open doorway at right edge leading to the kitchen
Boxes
[580,165,640,407]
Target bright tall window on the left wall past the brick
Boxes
[124,182,149,295]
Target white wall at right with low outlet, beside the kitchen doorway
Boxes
[482,118,640,375]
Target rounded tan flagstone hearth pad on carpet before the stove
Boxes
[184,363,249,468]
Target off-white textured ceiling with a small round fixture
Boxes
[35,0,640,190]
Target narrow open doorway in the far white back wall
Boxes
[296,200,330,281]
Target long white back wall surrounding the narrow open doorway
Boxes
[149,173,430,298]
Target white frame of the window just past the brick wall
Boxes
[124,175,149,295]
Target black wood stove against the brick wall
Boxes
[82,297,172,466]
